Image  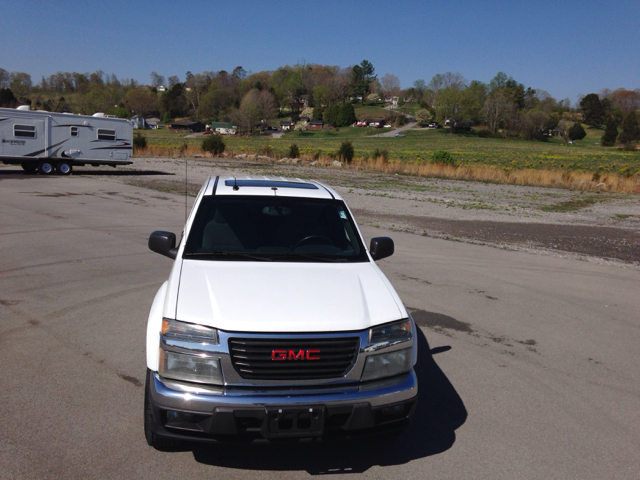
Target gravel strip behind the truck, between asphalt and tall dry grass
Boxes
[56,158,640,268]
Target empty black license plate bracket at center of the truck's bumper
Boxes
[264,405,325,438]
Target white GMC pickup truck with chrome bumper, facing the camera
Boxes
[144,177,418,448]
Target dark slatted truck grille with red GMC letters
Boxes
[229,337,360,380]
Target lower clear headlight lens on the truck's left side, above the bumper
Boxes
[158,348,223,385]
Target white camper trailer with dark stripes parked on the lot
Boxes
[0,107,133,175]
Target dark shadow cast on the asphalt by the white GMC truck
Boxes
[183,329,467,475]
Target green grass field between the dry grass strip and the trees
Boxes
[144,127,640,174]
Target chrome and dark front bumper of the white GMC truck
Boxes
[149,370,418,441]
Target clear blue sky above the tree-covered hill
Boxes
[0,0,640,102]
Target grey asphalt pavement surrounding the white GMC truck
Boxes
[0,173,640,479]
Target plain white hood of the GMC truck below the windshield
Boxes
[175,260,406,332]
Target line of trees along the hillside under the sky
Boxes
[0,60,640,145]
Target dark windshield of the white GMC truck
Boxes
[184,196,368,262]
